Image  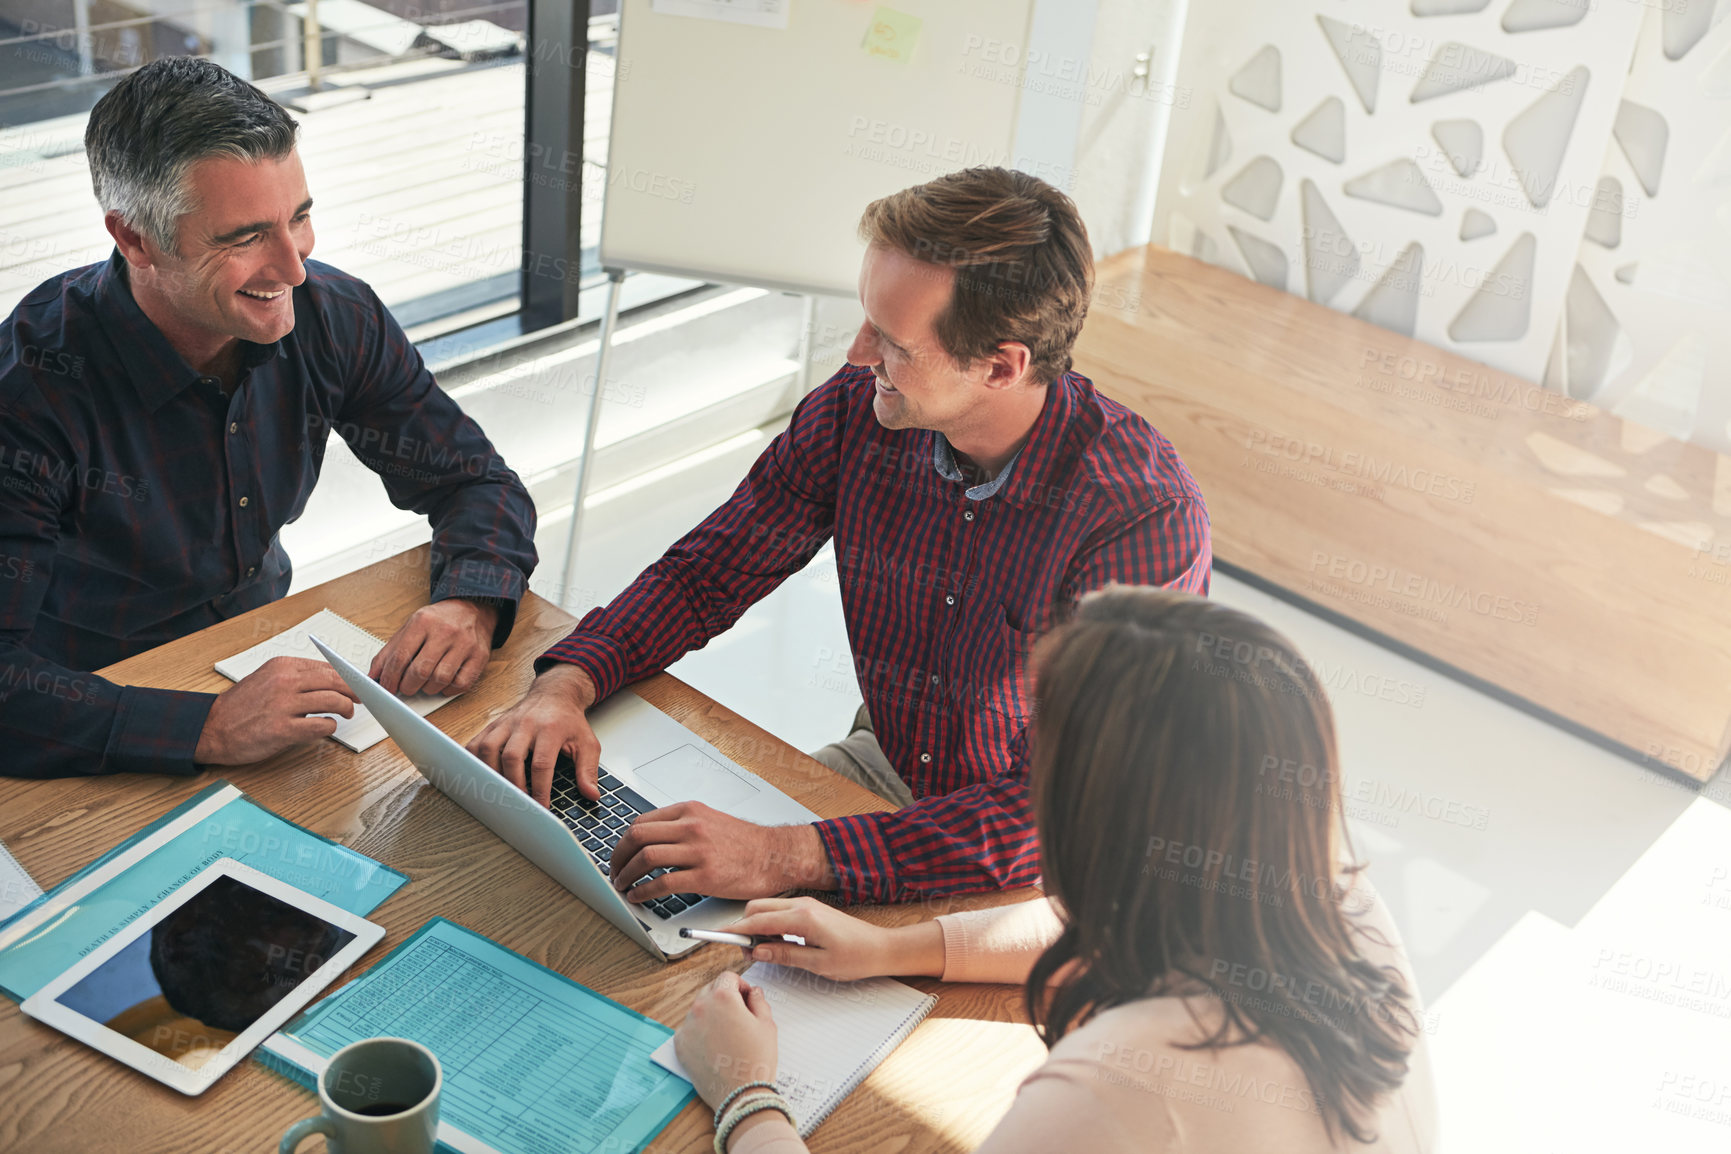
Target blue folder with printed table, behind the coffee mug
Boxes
[254,917,692,1154]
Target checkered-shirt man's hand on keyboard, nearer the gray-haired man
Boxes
[469,664,601,806]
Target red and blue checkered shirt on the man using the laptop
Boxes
[538,365,1213,901]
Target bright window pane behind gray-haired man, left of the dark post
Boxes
[0,0,530,332]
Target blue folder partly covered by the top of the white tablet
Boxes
[0,782,409,1002]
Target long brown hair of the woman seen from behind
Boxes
[1026,587,1418,1142]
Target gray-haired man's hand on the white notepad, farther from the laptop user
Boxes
[192,657,355,765]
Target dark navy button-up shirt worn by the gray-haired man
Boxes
[0,251,535,777]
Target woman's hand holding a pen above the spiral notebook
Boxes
[727,898,943,981]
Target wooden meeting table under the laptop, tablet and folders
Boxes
[0,547,1046,1154]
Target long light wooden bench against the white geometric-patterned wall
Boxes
[1075,246,1731,782]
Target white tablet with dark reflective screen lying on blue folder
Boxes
[23,858,384,1093]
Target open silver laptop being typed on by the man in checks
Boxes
[312,637,820,960]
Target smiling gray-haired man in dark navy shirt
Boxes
[0,57,535,777]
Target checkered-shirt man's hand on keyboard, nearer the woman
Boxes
[609,801,836,901]
